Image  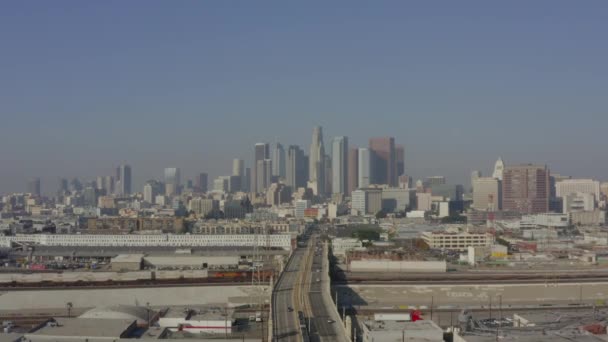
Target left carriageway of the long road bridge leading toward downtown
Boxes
[272,248,305,342]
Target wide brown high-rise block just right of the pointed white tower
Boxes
[497,165,550,214]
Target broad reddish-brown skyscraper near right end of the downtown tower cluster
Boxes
[369,137,397,186]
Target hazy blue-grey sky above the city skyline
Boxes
[0,0,608,193]
